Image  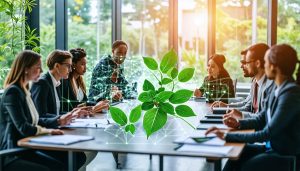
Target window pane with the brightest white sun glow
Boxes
[178,0,208,89]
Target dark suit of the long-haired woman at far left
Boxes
[0,84,85,170]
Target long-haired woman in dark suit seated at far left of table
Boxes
[0,50,84,170]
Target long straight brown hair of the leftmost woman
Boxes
[4,50,41,89]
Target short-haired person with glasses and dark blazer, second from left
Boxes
[31,50,89,118]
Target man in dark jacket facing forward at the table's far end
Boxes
[88,40,136,101]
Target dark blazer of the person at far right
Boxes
[225,81,300,155]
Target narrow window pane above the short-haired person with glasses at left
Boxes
[40,0,55,68]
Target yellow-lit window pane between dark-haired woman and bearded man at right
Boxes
[216,0,268,82]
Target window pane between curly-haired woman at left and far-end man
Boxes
[68,0,112,88]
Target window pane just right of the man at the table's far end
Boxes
[122,0,169,92]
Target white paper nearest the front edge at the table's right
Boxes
[177,144,233,156]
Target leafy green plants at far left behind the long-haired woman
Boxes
[0,0,40,89]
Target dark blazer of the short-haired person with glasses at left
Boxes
[30,72,61,118]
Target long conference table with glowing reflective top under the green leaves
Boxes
[18,100,245,171]
